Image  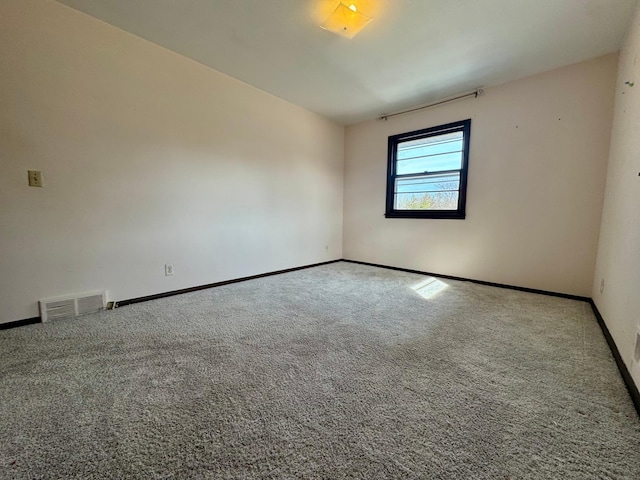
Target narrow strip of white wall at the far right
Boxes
[592,7,640,387]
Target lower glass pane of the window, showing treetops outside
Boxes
[394,173,460,210]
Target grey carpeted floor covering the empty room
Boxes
[0,262,640,479]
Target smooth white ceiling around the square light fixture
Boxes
[59,0,637,124]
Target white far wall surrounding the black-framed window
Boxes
[343,54,620,296]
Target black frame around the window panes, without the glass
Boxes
[385,118,471,220]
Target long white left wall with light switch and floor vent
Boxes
[0,0,344,322]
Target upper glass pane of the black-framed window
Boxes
[396,132,463,175]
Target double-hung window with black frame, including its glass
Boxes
[385,120,471,219]
